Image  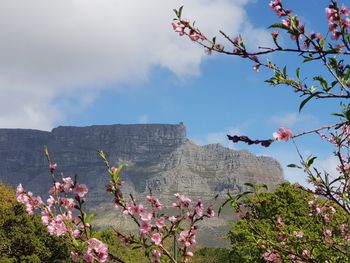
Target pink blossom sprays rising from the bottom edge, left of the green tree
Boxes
[16,148,215,263]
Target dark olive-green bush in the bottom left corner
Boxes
[0,183,69,263]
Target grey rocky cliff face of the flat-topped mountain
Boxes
[0,124,283,206]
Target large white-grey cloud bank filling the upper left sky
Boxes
[0,0,267,129]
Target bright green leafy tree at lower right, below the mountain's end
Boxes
[229,183,350,262]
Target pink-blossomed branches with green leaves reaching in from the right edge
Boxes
[172,0,350,262]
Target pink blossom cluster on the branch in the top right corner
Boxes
[326,2,350,40]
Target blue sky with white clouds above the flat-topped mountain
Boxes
[0,0,339,186]
